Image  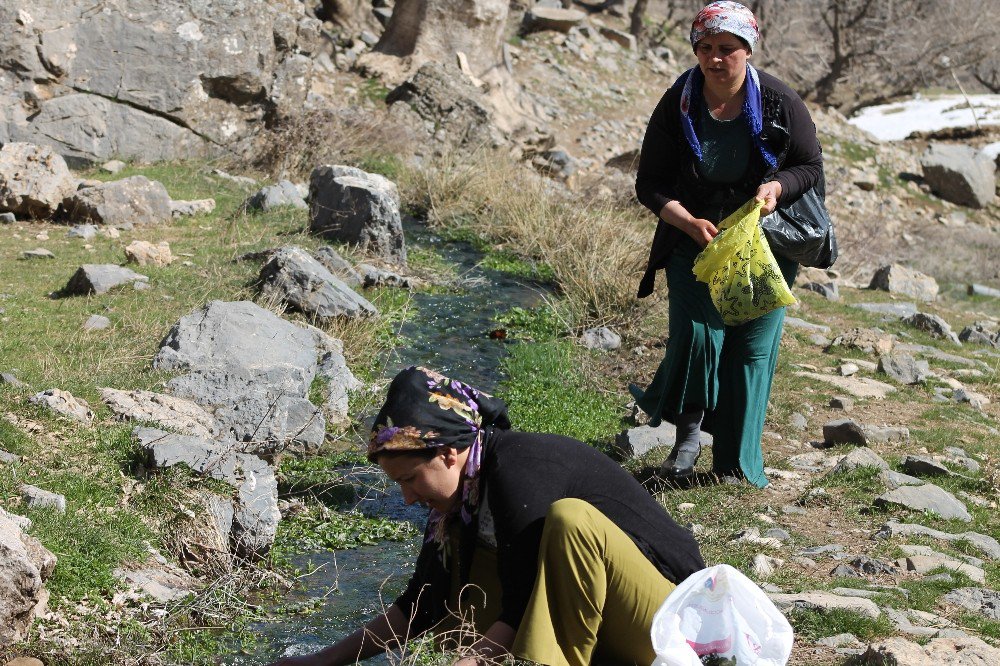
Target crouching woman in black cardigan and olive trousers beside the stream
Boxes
[268,368,705,666]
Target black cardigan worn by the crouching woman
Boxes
[395,430,705,634]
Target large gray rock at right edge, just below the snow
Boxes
[920,143,996,208]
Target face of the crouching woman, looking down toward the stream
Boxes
[378,447,468,513]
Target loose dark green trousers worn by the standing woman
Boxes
[635,236,798,488]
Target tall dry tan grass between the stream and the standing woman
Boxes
[401,150,650,326]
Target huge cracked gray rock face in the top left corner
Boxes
[0,0,321,164]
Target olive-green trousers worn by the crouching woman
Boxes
[448,499,676,666]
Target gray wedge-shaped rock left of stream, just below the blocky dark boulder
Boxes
[260,247,378,321]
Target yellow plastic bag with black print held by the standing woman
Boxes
[693,199,795,326]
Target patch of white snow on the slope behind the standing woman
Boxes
[848,95,1000,141]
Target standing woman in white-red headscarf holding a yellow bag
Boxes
[629,2,823,487]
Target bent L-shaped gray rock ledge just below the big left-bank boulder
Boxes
[133,428,281,556]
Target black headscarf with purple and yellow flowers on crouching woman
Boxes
[368,367,510,557]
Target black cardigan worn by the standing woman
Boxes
[635,71,823,298]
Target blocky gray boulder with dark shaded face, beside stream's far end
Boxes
[309,166,406,265]
